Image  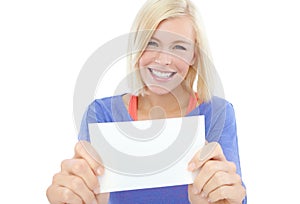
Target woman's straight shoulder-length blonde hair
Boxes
[128,0,213,103]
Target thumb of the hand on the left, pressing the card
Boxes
[74,141,104,176]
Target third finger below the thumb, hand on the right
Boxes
[208,184,246,203]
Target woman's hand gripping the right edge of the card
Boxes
[188,142,246,204]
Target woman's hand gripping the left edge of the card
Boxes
[47,141,109,204]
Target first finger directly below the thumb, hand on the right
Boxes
[194,160,235,193]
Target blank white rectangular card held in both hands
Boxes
[89,116,205,193]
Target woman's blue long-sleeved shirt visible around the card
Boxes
[78,95,247,204]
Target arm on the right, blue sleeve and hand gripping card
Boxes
[189,103,246,203]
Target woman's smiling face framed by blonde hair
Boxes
[139,16,195,95]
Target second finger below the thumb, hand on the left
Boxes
[53,173,97,204]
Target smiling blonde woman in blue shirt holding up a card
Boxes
[47,0,246,204]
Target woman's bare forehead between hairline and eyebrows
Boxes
[153,16,195,42]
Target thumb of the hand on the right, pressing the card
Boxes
[188,142,226,171]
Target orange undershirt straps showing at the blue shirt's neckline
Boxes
[128,94,198,121]
